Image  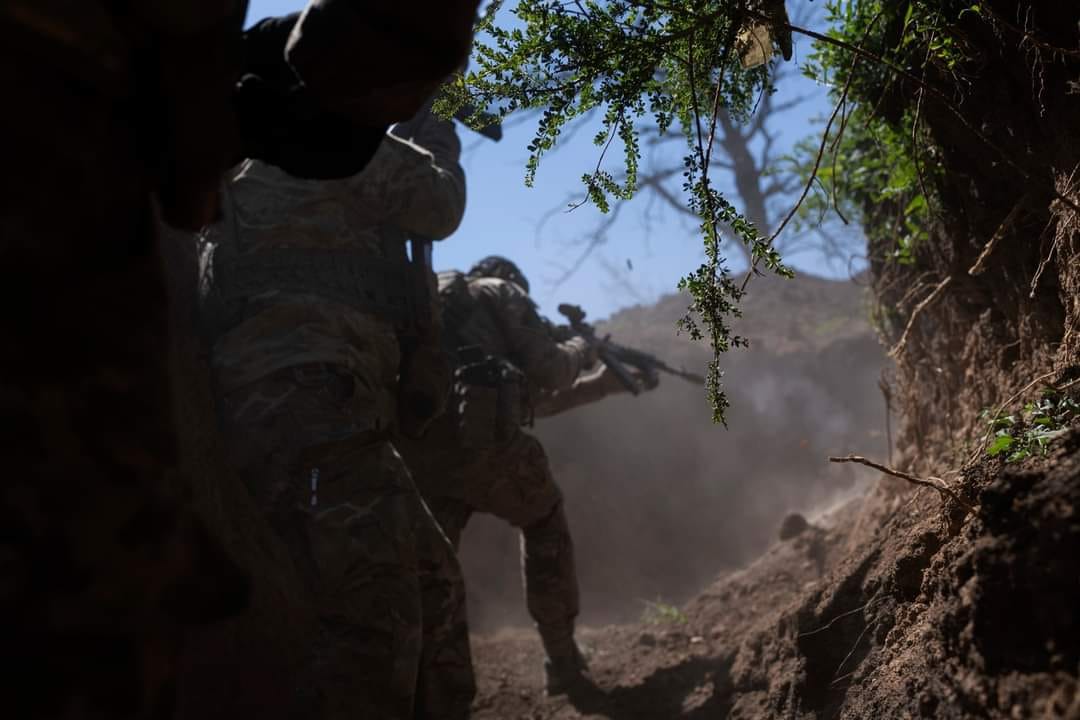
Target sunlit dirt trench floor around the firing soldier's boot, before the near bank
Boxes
[473,492,864,720]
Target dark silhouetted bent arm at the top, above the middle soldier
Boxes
[286,0,480,124]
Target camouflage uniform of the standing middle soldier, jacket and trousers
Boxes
[207,108,474,720]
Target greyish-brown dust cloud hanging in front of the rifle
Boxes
[461,277,888,633]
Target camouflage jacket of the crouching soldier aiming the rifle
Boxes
[438,272,586,394]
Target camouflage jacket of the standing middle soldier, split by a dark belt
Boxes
[207,107,465,389]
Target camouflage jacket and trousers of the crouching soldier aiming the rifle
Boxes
[402,273,600,682]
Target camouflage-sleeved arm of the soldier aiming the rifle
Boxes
[487,283,589,393]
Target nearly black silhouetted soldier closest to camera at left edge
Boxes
[0,0,477,718]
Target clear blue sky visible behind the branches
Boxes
[248,0,846,318]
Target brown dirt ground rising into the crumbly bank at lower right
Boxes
[474,432,1080,720]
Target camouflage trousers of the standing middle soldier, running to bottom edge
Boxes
[224,364,475,720]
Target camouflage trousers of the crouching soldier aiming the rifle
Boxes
[402,423,579,657]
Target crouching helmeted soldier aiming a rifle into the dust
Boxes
[401,257,656,694]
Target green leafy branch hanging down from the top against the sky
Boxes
[436,0,791,422]
